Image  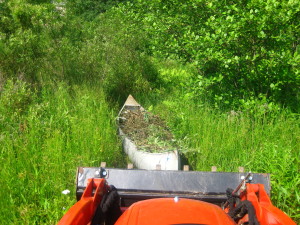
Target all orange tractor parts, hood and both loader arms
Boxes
[58,179,296,225]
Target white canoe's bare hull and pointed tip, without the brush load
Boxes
[119,95,180,170]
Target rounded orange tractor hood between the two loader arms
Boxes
[115,198,236,225]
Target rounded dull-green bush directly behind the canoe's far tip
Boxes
[70,11,158,99]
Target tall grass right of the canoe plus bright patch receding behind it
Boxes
[142,63,300,221]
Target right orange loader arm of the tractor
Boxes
[238,184,296,225]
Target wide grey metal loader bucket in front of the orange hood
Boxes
[76,167,271,206]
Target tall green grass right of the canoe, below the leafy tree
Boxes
[157,98,300,220]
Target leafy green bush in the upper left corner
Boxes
[0,0,55,82]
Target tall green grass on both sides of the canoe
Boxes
[0,75,300,224]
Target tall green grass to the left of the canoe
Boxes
[0,81,124,224]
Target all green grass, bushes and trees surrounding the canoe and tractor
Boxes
[0,0,300,224]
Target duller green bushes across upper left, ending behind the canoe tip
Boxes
[0,0,157,99]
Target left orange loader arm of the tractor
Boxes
[58,179,107,225]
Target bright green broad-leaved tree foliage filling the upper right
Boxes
[118,0,300,110]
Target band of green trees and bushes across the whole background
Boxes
[0,0,300,112]
